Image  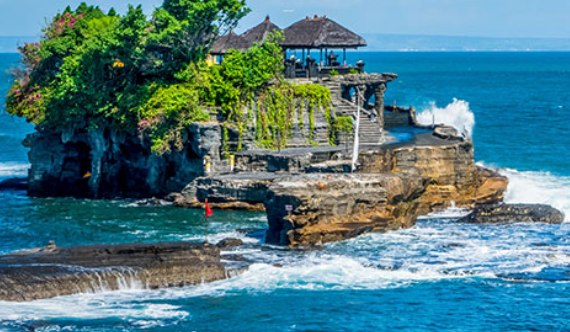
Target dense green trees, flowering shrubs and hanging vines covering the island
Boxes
[6,0,337,154]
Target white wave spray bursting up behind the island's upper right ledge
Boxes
[417,98,475,137]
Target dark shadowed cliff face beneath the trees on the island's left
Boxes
[25,124,229,198]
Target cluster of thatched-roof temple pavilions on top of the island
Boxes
[207,15,366,78]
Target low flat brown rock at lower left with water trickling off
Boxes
[0,242,232,301]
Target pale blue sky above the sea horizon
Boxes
[0,0,570,38]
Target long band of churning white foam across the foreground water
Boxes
[0,215,570,325]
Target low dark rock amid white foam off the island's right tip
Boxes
[459,204,564,224]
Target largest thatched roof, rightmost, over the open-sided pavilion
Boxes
[281,16,366,49]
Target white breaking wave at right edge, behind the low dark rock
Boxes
[500,169,570,221]
